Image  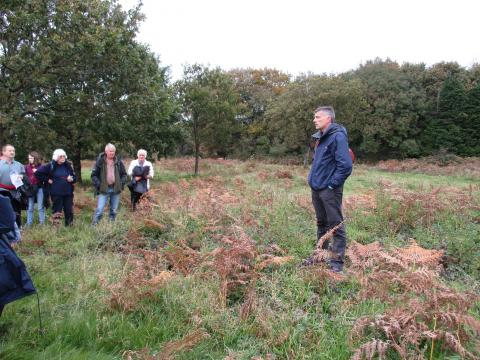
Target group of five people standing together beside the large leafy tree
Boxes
[0,144,154,235]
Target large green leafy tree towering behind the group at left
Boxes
[0,0,174,180]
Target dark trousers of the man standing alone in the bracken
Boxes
[312,186,347,268]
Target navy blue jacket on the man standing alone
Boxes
[308,123,352,190]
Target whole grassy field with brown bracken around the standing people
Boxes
[0,159,480,360]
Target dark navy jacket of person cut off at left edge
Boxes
[0,195,36,309]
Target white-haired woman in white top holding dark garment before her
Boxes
[127,149,154,210]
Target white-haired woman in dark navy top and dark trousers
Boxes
[35,149,77,226]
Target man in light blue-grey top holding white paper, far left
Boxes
[0,144,25,228]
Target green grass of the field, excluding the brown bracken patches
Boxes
[0,161,480,359]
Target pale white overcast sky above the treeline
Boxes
[120,0,480,79]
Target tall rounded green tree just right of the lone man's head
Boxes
[354,59,426,158]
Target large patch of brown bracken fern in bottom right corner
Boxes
[348,241,480,359]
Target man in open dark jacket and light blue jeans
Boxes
[91,144,127,225]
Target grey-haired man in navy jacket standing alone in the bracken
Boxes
[306,106,352,272]
